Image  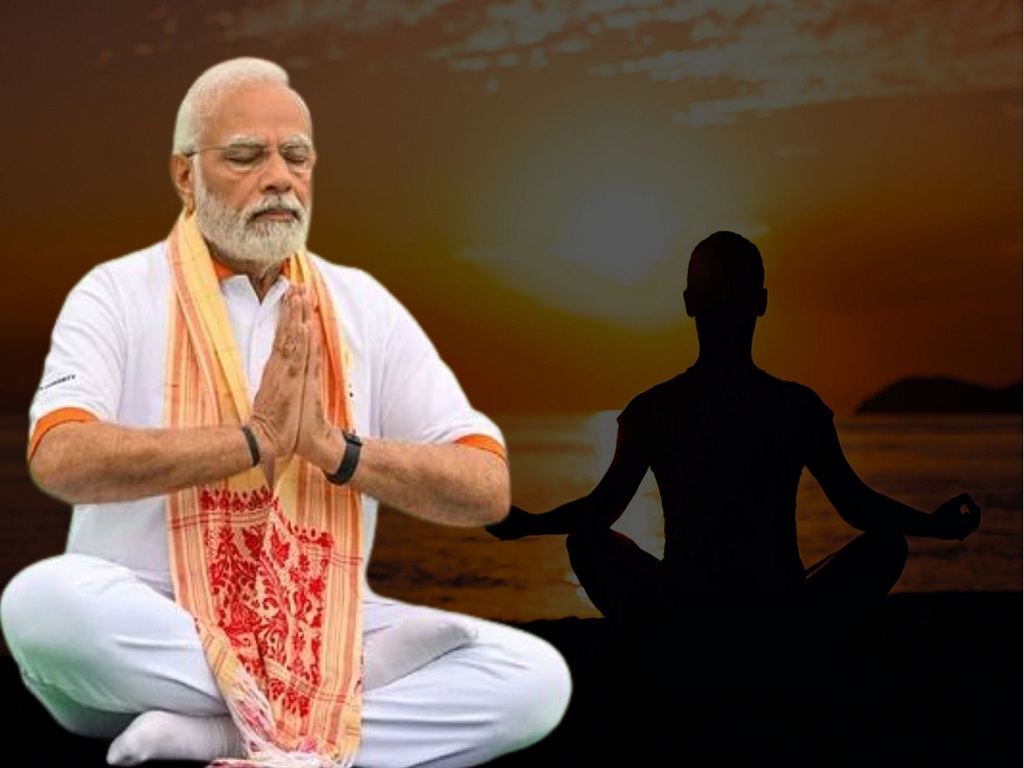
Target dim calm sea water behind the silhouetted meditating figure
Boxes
[0,412,1024,622]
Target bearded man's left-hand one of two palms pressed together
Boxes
[250,286,311,462]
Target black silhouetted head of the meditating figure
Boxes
[683,231,768,319]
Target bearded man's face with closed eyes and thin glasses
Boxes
[190,84,313,269]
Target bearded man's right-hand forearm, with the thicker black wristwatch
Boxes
[331,438,509,526]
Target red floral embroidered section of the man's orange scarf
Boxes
[199,488,334,717]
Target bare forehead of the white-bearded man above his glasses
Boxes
[202,83,311,144]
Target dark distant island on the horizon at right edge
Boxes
[854,377,1022,414]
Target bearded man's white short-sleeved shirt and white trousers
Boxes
[0,244,570,767]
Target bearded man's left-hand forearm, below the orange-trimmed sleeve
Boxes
[29,421,260,504]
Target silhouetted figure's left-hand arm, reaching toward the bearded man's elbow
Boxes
[486,430,650,540]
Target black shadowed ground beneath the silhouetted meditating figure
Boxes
[0,592,1022,768]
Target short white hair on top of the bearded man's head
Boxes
[173,56,311,155]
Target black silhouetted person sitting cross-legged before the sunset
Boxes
[487,231,981,651]
